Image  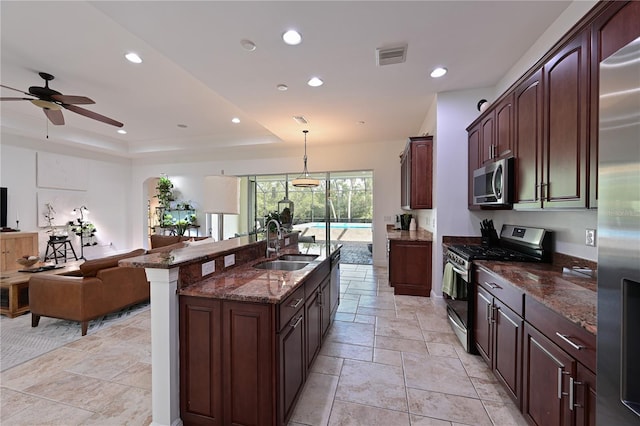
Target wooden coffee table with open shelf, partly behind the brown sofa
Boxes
[0,260,84,318]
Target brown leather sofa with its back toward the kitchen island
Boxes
[29,249,150,336]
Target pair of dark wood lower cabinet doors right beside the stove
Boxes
[474,275,524,407]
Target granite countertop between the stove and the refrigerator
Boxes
[473,260,598,335]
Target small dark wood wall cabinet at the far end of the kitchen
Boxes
[400,136,433,210]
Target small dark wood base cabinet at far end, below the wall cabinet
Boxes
[389,240,432,297]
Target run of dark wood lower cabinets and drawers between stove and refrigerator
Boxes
[474,266,596,426]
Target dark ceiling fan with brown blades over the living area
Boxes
[0,72,124,127]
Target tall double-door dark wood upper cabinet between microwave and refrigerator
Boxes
[513,31,589,210]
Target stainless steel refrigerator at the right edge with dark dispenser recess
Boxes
[596,38,640,426]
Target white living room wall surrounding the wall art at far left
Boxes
[0,133,135,258]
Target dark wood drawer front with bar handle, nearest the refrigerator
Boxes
[524,297,596,371]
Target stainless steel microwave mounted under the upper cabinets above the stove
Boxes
[473,157,513,207]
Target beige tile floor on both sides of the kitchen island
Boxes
[0,265,526,426]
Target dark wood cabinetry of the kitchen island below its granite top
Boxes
[179,253,332,426]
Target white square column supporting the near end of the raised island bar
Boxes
[145,268,182,426]
